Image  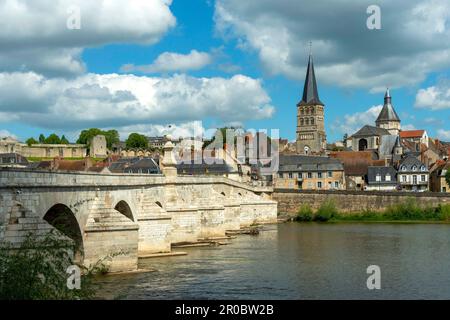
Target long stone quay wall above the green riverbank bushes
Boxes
[272,190,450,215]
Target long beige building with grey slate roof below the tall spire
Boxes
[273,155,345,190]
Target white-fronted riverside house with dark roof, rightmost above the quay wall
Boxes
[397,155,430,191]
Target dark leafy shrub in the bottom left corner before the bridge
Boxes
[0,232,109,300]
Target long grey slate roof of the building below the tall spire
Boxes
[278,155,344,172]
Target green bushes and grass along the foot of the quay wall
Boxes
[295,198,450,223]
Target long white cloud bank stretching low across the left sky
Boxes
[0,72,275,130]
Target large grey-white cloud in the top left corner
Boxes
[0,0,176,75]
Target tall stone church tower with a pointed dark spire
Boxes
[297,54,327,154]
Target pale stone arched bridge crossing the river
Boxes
[0,165,277,271]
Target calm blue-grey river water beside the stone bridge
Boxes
[97,223,450,299]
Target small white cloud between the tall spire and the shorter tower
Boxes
[332,105,383,136]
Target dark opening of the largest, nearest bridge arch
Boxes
[44,203,84,261]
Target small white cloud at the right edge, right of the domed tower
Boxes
[415,81,450,110]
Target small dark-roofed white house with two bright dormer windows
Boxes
[365,166,398,191]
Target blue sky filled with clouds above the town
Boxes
[0,0,450,142]
